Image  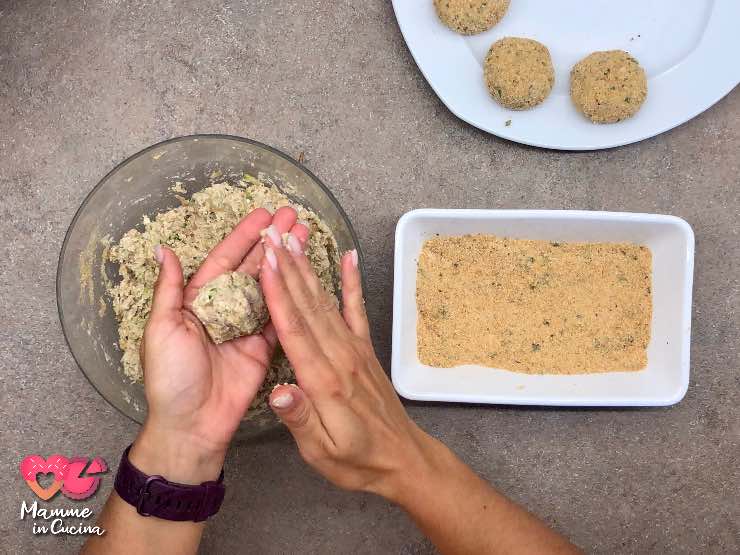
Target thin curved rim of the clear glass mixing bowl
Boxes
[54,133,367,425]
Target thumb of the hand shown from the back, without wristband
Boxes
[270,385,333,454]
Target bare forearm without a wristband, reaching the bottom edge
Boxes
[392,435,579,555]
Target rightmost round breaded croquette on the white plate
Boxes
[570,50,647,123]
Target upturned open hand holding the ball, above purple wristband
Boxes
[129,207,308,483]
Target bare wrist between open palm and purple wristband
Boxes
[129,422,226,485]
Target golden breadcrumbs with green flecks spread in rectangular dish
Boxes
[416,235,652,374]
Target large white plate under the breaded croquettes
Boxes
[393,0,740,150]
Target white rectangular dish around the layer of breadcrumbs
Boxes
[391,209,694,406]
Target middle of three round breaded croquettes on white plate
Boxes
[483,37,555,110]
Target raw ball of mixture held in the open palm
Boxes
[193,272,270,344]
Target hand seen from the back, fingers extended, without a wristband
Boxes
[260,232,430,500]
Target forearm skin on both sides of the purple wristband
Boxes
[82,426,223,555]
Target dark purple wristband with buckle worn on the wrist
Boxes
[114,445,225,522]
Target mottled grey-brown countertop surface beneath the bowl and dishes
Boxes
[0,0,740,554]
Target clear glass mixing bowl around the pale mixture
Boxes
[56,135,364,438]
